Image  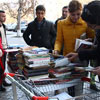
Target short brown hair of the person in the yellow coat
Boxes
[68,0,82,12]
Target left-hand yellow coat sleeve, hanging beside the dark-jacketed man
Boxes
[54,20,63,52]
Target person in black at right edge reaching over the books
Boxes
[66,1,100,75]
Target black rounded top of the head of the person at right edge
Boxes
[82,1,100,25]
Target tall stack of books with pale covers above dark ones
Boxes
[20,48,50,78]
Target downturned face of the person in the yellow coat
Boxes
[69,10,82,23]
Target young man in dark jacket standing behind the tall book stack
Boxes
[23,5,56,49]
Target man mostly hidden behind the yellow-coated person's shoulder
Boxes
[55,6,68,31]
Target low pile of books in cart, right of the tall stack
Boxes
[48,67,86,81]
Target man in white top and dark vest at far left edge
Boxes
[0,10,11,91]
